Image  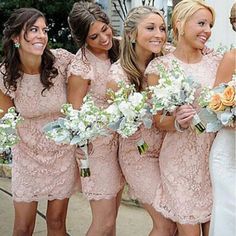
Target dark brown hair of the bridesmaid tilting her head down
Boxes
[68,1,119,63]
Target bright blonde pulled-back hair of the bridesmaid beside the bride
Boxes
[171,0,215,42]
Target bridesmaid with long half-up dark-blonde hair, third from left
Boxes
[107,6,175,236]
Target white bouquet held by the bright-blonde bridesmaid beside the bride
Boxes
[149,61,205,133]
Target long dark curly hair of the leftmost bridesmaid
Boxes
[0,8,58,94]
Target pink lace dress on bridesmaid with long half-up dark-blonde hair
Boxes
[109,61,165,204]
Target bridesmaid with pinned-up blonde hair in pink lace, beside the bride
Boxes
[145,0,220,236]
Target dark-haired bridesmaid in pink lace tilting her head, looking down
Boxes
[68,2,124,236]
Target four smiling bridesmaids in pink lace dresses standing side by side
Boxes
[0,0,236,236]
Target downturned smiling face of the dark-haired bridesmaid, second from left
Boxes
[86,21,113,52]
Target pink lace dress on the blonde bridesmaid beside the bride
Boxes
[145,53,220,224]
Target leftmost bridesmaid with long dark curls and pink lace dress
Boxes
[0,8,78,235]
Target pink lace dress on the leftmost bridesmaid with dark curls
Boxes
[0,49,78,202]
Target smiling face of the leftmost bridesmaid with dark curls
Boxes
[14,17,48,56]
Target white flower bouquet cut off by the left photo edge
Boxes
[0,107,22,153]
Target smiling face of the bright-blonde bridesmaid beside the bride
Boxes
[180,8,213,49]
